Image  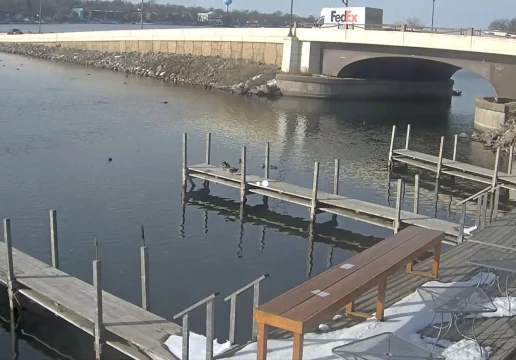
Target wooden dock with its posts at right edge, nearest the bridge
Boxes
[388,125,516,190]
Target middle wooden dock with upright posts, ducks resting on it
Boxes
[183,134,467,243]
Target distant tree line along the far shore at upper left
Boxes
[0,0,317,26]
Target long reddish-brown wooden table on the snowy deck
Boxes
[254,226,445,360]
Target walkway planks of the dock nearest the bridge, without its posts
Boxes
[392,149,516,190]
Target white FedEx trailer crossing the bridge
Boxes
[320,7,383,29]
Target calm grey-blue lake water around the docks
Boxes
[0,54,502,360]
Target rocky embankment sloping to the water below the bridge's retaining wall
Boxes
[0,43,281,97]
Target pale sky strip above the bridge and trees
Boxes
[136,0,516,29]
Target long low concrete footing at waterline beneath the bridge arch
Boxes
[276,74,454,99]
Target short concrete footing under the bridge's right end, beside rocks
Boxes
[475,97,516,131]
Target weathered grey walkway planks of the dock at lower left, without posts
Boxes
[0,246,181,360]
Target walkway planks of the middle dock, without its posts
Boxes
[188,164,459,243]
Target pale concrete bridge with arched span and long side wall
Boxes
[0,26,516,98]
